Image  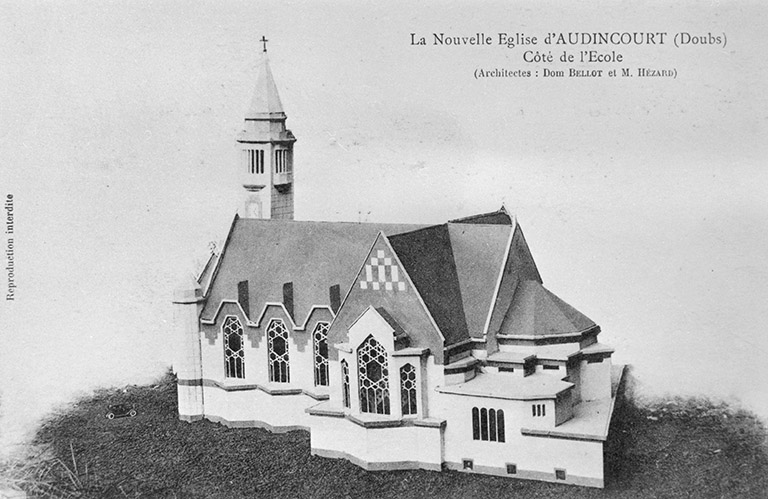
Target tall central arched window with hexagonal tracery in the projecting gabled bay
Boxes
[357,336,389,414]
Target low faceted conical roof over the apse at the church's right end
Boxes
[499,281,596,336]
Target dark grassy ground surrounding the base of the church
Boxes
[5,370,768,499]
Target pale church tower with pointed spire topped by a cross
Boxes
[237,36,296,220]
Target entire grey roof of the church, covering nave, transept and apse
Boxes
[201,212,596,347]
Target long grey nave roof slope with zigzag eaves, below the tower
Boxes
[202,217,423,324]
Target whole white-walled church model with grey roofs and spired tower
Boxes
[174,45,622,487]
